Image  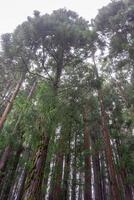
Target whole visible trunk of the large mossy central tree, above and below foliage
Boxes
[22,52,63,200]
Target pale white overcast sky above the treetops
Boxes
[0,0,110,35]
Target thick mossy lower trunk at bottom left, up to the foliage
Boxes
[22,135,49,200]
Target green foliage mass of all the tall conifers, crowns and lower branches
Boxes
[0,4,134,198]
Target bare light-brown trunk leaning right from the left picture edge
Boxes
[0,75,24,129]
